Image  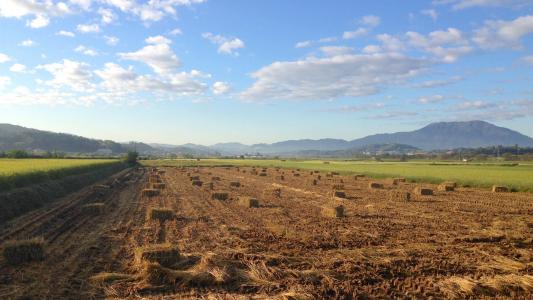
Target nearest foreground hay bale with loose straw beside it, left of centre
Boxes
[135,244,181,268]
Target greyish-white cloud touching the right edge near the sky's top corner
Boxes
[473,15,533,49]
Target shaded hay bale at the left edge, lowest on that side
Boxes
[3,238,44,265]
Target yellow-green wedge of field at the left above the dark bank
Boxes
[0,159,120,191]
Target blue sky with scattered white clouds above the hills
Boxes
[0,0,533,145]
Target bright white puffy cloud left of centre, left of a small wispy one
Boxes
[119,36,181,74]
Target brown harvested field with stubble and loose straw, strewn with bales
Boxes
[0,167,533,299]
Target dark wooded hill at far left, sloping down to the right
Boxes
[0,124,127,153]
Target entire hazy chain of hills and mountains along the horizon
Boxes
[0,121,533,156]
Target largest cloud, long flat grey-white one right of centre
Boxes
[241,53,429,101]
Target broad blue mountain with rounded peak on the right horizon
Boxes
[350,121,533,150]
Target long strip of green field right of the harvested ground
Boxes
[142,159,533,192]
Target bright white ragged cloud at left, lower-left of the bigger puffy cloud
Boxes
[37,59,93,91]
